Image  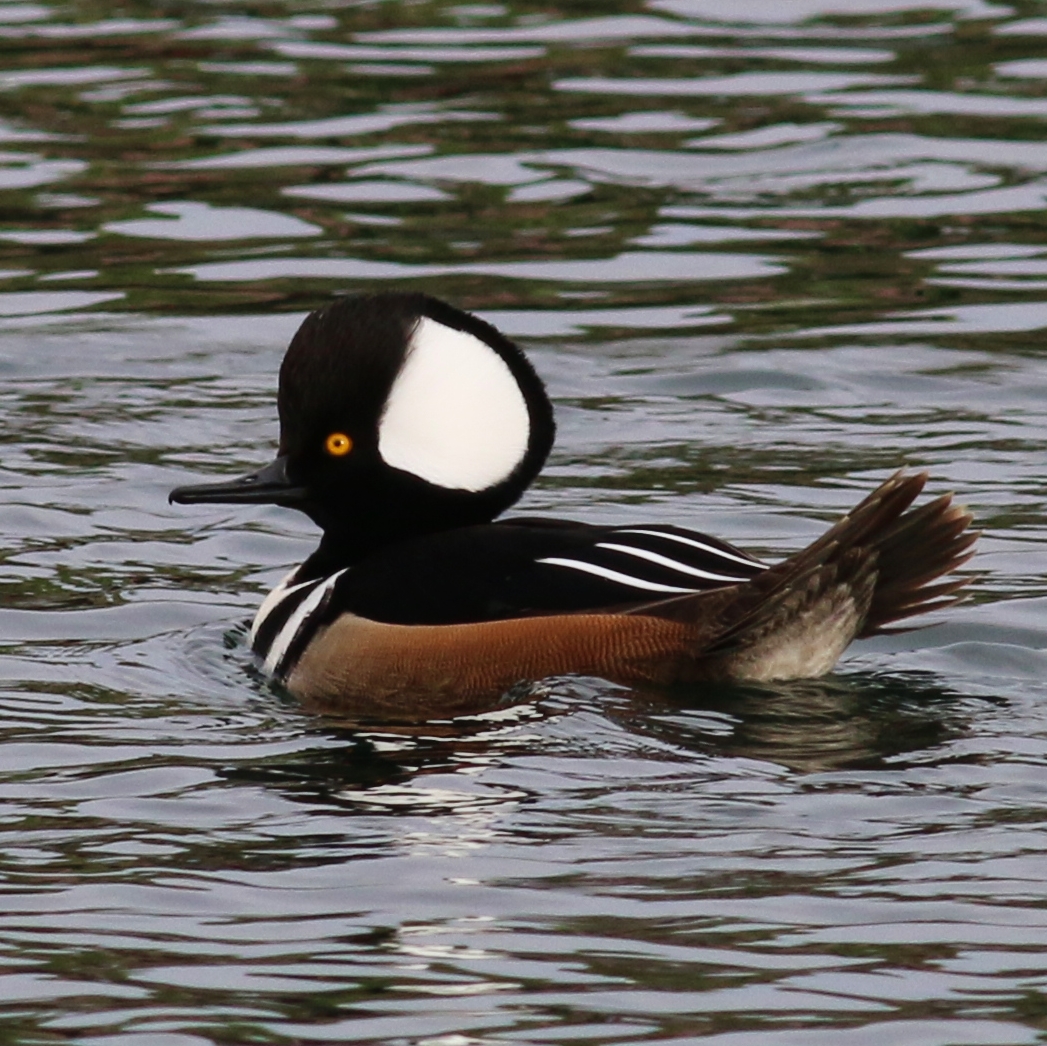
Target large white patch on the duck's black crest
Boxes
[378,316,531,490]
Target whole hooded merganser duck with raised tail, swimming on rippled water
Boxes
[171,293,976,719]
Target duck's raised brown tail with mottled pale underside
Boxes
[632,472,977,680]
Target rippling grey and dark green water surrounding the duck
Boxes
[0,0,1047,1046]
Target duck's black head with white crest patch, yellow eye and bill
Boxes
[171,293,555,553]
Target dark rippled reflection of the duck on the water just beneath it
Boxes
[216,672,975,816]
